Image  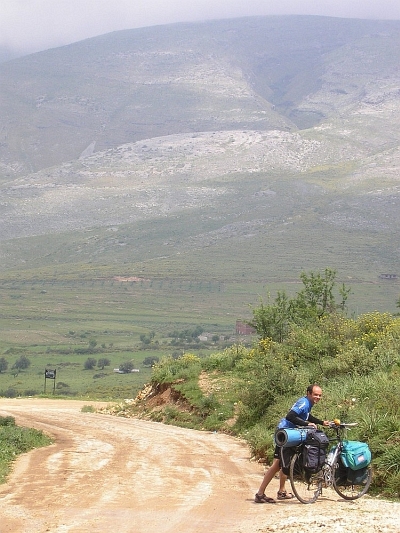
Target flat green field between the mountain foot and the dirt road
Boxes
[0,262,398,399]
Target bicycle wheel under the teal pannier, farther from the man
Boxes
[333,461,372,500]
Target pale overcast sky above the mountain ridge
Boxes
[0,0,400,55]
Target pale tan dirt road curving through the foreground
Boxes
[0,399,400,533]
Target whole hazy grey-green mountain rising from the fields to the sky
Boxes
[0,16,400,316]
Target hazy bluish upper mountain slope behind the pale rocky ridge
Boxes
[0,16,400,175]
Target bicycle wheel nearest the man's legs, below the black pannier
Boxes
[289,451,322,503]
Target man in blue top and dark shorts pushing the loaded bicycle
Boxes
[254,384,329,503]
